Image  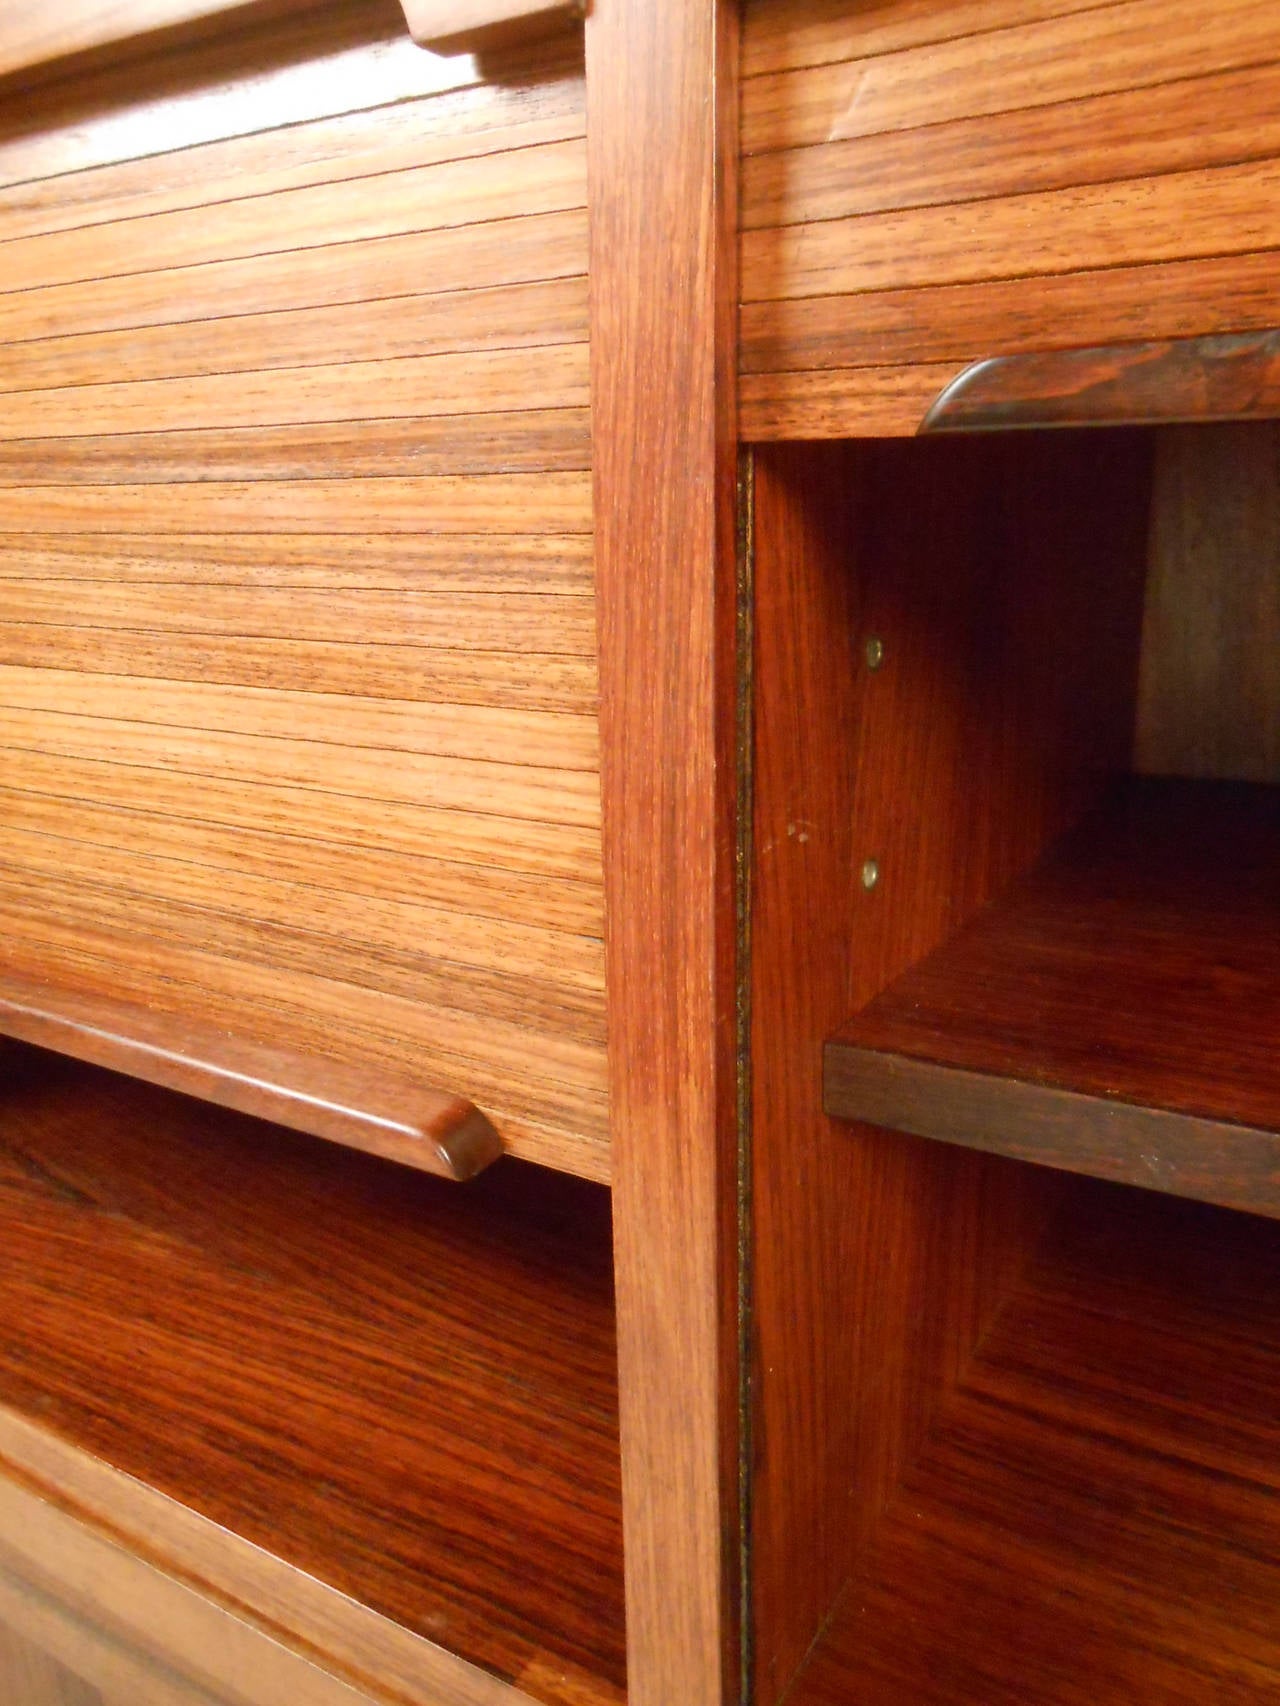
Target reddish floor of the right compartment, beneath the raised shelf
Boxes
[788,1184,1280,1706]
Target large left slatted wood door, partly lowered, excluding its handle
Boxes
[0,0,608,1177]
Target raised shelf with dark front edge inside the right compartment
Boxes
[824,781,1280,1215]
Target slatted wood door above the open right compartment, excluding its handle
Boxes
[742,0,1280,438]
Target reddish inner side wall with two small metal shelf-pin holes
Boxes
[751,435,1149,1706]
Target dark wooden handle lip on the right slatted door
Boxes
[920,331,1280,433]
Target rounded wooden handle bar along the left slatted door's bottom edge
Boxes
[0,972,502,1179]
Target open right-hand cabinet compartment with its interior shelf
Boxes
[751,423,1280,1706]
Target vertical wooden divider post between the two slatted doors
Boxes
[587,0,739,1706]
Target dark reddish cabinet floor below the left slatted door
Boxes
[0,1044,625,1706]
